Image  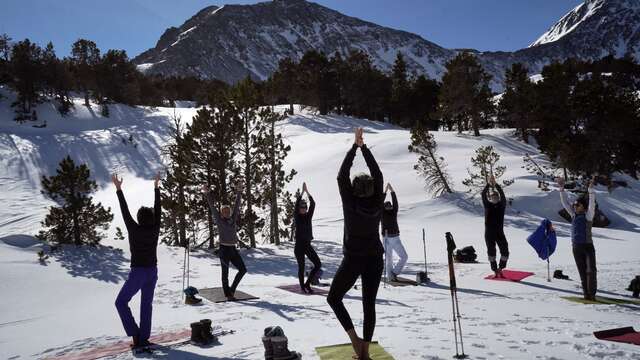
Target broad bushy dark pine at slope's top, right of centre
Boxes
[438,52,494,136]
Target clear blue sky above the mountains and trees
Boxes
[0,0,583,57]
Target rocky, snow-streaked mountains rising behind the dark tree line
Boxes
[134,0,640,90]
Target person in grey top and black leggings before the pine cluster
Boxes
[202,183,247,301]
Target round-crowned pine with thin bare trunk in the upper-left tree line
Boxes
[71,39,100,107]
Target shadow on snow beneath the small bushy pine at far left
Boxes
[49,245,129,283]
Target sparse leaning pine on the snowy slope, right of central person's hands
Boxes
[409,123,453,196]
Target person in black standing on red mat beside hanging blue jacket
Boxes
[482,176,509,277]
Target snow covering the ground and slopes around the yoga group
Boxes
[0,92,640,359]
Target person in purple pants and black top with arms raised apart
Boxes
[111,174,161,347]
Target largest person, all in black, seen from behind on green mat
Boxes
[327,128,385,359]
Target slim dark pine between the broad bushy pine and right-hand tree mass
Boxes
[498,63,535,143]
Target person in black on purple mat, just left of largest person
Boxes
[293,183,322,294]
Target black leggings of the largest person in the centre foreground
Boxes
[327,255,384,341]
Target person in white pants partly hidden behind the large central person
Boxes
[382,184,407,281]
